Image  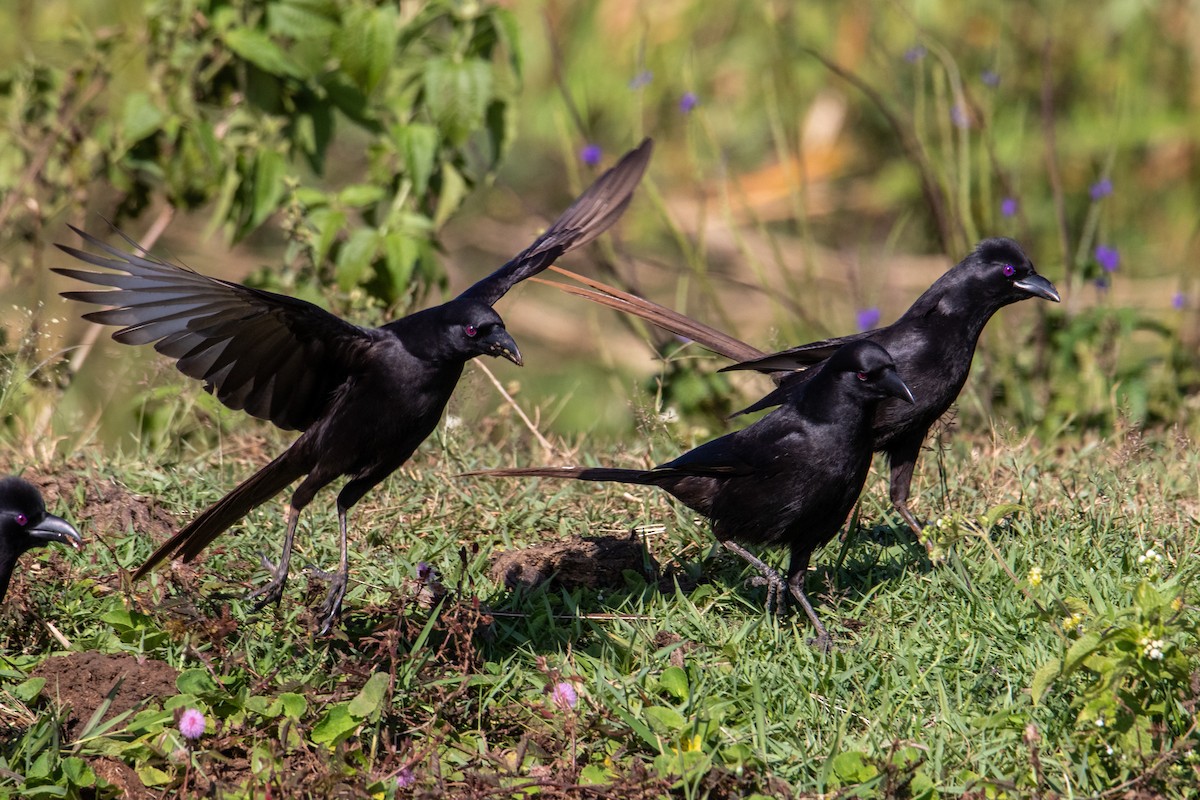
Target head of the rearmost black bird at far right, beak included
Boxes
[934,237,1060,312]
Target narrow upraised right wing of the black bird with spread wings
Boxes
[460,139,653,305]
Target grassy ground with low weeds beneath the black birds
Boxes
[0,381,1200,798]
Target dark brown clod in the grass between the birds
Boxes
[491,536,659,590]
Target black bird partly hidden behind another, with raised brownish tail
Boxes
[540,239,1058,546]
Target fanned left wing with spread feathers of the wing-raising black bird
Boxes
[54,227,377,429]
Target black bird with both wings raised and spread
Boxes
[55,139,652,633]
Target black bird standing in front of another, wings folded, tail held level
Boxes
[470,342,913,646]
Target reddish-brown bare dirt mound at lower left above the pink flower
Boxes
[32,652,179,740]
